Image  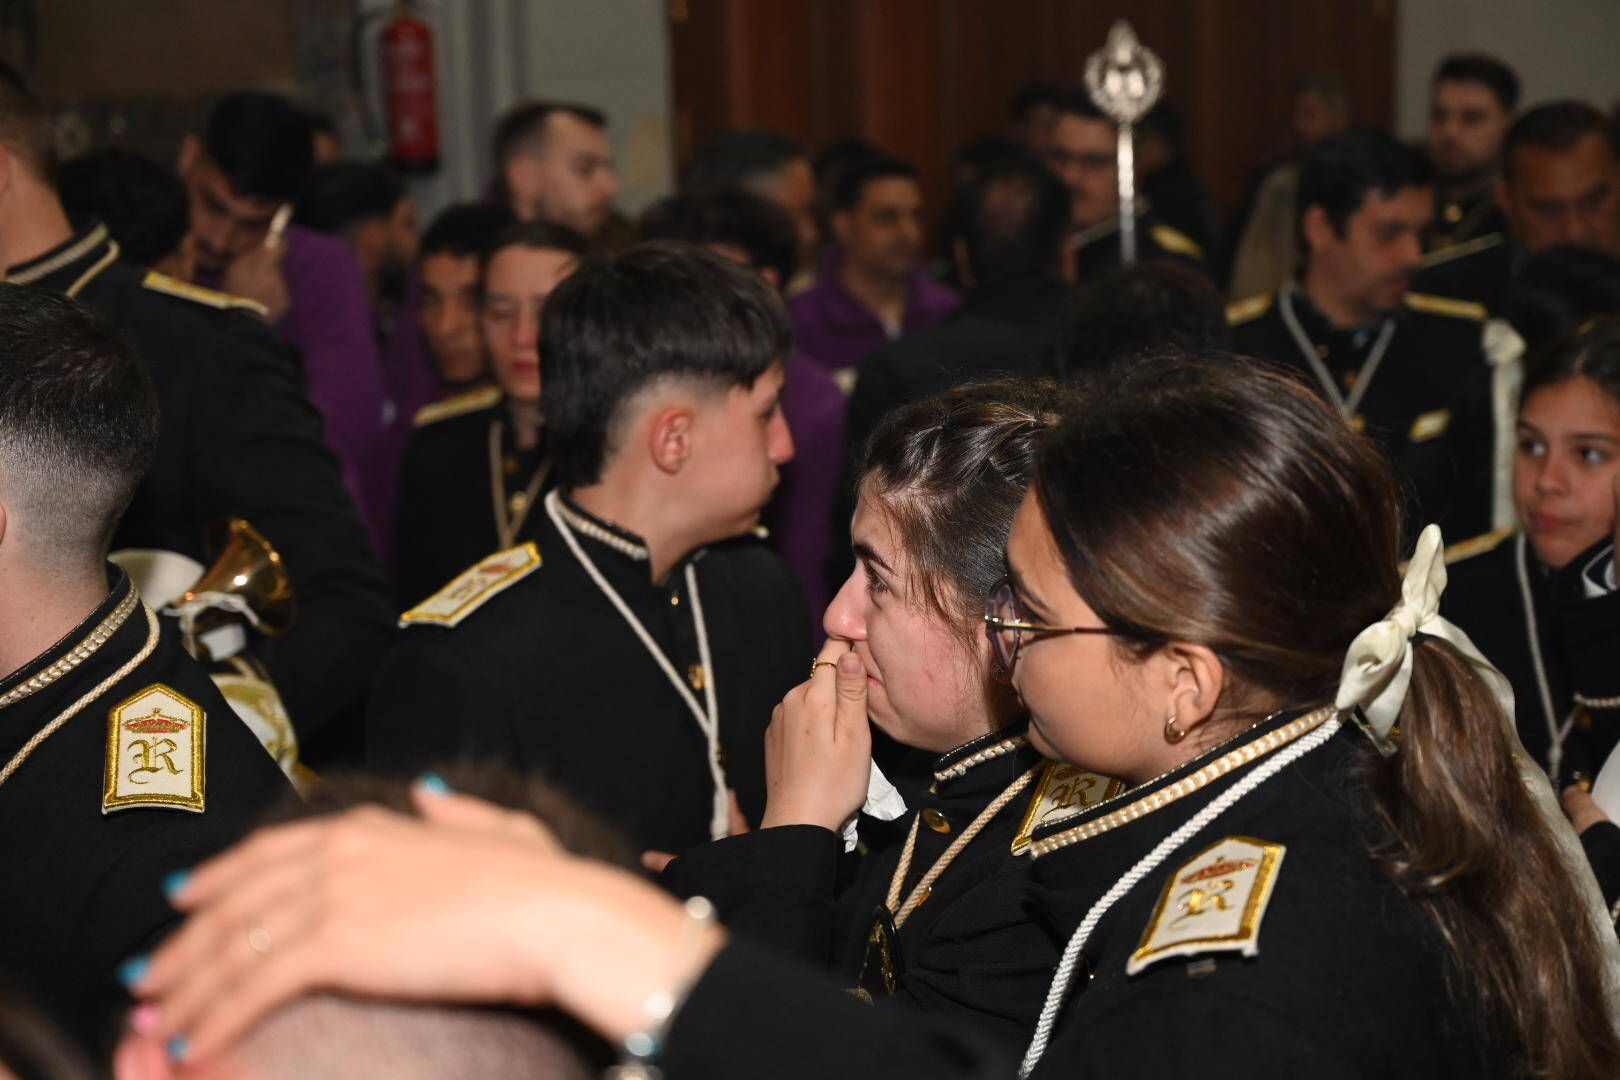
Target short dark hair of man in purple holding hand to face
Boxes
[203,92,314,202]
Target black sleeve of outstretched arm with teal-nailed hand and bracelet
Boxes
[659,941,997,1080]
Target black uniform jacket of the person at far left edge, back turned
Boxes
[0,572,292,1051]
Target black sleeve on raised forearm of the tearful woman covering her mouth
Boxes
[659,826,839,967]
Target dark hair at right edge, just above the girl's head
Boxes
[1507,244,1620,351]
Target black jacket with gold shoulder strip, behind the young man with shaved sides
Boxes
[394,389,551,609]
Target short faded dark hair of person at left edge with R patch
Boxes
[0,283,157,568]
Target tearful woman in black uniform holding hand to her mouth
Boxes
[664,381,1124,1049]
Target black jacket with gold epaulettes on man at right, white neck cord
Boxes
[1226,288,1495,539]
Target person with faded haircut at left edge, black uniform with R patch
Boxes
[0,285,290,1052]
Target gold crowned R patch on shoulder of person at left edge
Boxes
[102,683,207,814]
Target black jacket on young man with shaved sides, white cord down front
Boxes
[366,504,812,852]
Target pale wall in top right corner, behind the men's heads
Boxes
[1395,0,1620,138]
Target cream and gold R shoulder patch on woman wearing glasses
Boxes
[1124,836,1285,975]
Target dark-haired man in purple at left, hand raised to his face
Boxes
[180,92,394,549]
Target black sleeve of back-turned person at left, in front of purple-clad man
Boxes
[193,316,392,743]
